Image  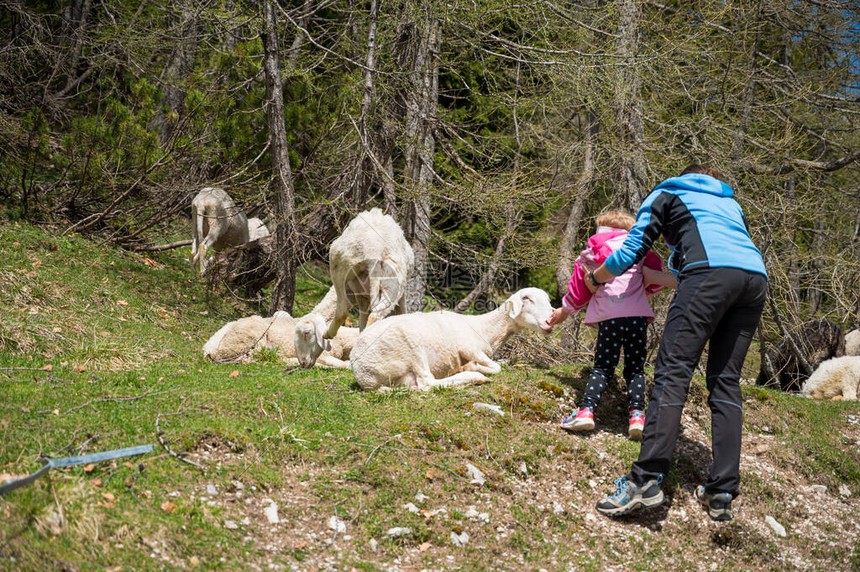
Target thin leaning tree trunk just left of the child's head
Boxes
[555,111,597,298]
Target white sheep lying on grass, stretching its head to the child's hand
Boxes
[351,288,552,390]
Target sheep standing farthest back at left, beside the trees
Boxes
[191,187,254,274]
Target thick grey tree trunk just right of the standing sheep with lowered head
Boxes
[404,8,441,312]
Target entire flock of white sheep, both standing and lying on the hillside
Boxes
[191,187,860,399]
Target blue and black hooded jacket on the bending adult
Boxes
[605,173,767,276]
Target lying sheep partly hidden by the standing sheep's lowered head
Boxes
[203,288,358,369]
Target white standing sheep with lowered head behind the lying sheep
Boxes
[294,208,414,367]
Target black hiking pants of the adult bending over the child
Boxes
[628,268,767,496]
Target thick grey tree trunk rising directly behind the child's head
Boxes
[615,0,648,211]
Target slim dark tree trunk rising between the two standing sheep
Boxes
[263,0,296,313]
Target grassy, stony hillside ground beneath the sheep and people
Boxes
[0,224,860,570]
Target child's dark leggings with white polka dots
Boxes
[579,316,648,411]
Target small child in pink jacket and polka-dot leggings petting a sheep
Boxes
[548,211,675,440]
